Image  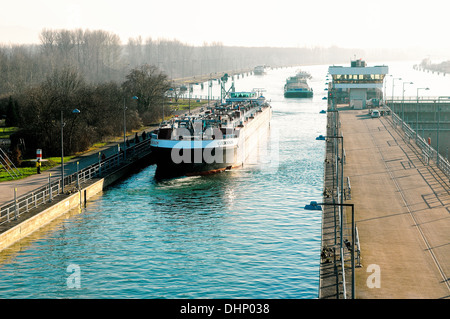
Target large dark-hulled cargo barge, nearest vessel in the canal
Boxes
[151,91,272,179]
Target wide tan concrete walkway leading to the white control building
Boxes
[339,110,450,299]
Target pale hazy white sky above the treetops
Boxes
[0,0,450,50]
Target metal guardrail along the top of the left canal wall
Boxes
[0,138,150,225]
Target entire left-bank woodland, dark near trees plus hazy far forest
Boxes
[0,29,412,162]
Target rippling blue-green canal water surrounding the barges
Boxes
[0,66,334,298]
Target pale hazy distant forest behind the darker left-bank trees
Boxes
[0,29,370,94]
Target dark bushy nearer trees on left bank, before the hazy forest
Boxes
[6,65,170,161]
